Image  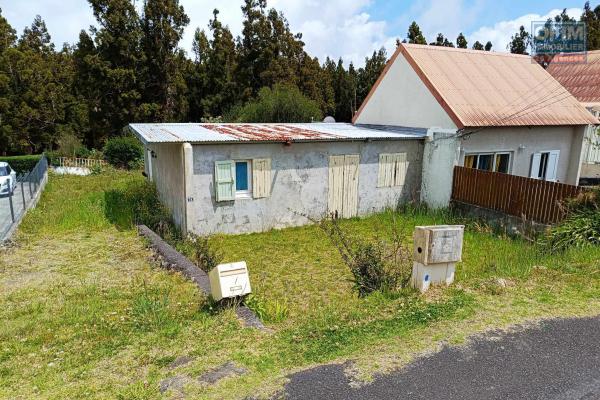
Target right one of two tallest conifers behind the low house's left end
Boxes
[141,0,190,121]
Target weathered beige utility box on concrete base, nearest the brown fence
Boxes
[412,225,465,292]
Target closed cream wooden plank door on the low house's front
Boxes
[328,154,360,218]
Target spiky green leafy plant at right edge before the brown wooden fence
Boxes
[541,188,600,252]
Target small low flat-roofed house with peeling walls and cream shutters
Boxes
[129,123,426,234]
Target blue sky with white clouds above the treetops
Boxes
[0,0,600,66]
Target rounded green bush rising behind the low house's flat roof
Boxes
[225,85,323,123]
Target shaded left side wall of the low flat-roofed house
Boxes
[145,143,186,230]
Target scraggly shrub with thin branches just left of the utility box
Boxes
[319,218,412,296]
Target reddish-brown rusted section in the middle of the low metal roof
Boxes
[200,124,338,142]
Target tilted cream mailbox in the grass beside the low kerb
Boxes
[208,261,252,301]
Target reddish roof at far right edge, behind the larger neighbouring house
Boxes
[546,50,600,107]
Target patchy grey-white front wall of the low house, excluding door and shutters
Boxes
[187,140,423,234]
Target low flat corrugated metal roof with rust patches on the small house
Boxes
[129,123,427,143]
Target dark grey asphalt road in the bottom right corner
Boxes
[285,317,600,400]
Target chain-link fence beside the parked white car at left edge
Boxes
[0,155,48,243]
